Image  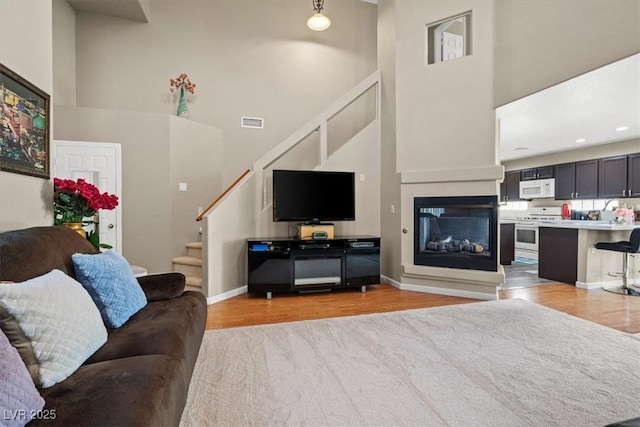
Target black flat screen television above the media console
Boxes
[273,169,356,224]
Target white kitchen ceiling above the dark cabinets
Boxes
[496,54,640,161]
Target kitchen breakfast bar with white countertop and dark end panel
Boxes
[537,220,640,289]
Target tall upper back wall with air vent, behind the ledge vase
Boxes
[76,0,376,187]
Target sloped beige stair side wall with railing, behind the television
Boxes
[197,70,381,300]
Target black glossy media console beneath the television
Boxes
[247,236,380,299]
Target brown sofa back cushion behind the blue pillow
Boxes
[0,226,98,282]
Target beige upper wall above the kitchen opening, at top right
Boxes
[494,0,640,106]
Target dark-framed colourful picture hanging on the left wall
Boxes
[0,64,51,179]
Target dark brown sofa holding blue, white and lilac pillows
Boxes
[0,227,207,426]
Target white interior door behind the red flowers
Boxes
[53,141,122,253]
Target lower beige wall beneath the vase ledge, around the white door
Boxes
[55,106,223,273]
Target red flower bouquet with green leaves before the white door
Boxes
[53,178,118,225]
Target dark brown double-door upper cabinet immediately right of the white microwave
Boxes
[554,160,598,200]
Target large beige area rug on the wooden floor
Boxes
[181,300,640,427]
